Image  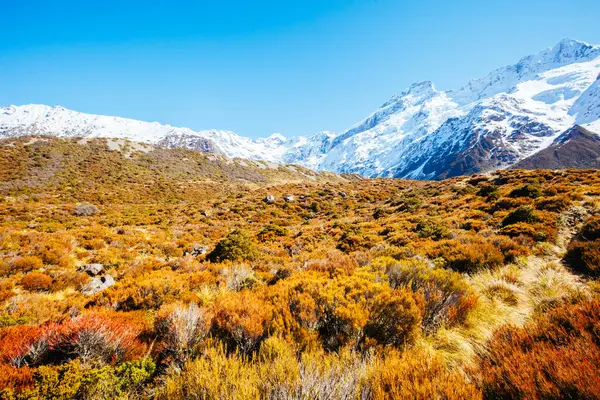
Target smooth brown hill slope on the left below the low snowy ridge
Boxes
[0,136,358,202]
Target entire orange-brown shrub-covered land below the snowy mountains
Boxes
[0,137,600,399]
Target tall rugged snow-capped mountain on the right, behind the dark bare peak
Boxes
[298,40,600,179]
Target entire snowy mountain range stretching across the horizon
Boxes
[0,39,600,179]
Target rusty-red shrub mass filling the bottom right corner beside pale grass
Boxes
[479,300,600,399]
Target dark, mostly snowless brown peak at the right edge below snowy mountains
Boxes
[513,125,600,169]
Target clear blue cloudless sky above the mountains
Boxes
[0,0,600,137]
